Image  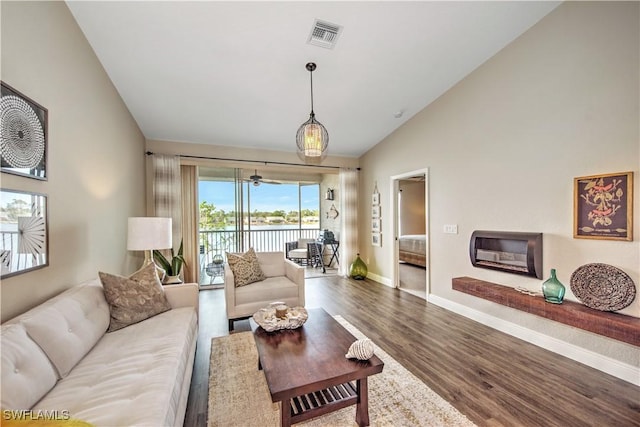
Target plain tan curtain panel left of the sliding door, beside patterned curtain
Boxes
[180,165,200,283]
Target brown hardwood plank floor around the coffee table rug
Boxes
[185,276,640,427]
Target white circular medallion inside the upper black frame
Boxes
[0,95,45,169]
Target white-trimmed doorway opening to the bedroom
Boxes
[391,169,430,300]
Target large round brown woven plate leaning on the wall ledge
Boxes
[571,263,636,311]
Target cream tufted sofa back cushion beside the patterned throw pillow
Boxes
[21,281,109,378]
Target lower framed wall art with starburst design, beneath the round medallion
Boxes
[0,188,49,279]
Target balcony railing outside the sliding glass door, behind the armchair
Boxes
[200,228,320,283]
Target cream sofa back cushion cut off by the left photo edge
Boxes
[0,324,58,409]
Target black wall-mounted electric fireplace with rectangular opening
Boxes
[469,230,542,279]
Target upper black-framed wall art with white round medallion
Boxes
[0,82,48,180]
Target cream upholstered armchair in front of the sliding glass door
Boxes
[224,252,305,331]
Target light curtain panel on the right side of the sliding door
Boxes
[338,169,358,276]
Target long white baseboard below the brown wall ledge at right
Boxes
[428,294,640,386]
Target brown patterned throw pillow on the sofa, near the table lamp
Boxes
[98,264,171,332]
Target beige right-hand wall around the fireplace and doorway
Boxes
[359,2,640,370]
